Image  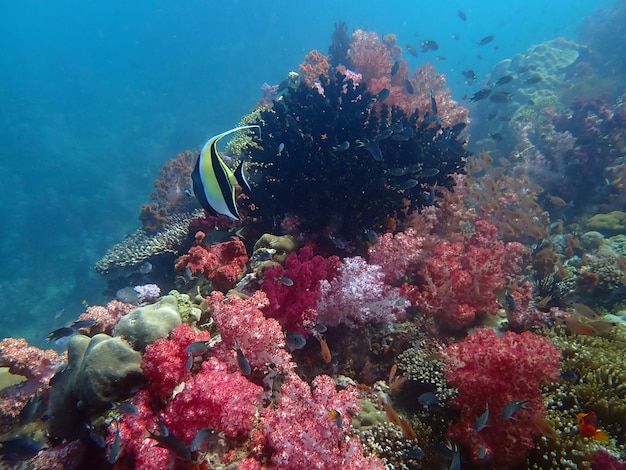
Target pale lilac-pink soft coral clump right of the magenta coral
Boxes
[317,256,410,326]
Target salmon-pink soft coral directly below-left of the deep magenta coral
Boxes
[207,291,295,372]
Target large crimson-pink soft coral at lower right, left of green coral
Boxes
[441,330,561,467]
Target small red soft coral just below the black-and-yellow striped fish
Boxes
[176,232,248,292]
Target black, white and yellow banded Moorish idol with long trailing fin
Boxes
[191,125,260,220]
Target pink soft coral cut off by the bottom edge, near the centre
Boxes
[262,373,383,470]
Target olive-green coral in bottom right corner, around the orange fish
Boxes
[527,326,626,469]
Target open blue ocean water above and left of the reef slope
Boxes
[0,0,615,346]
